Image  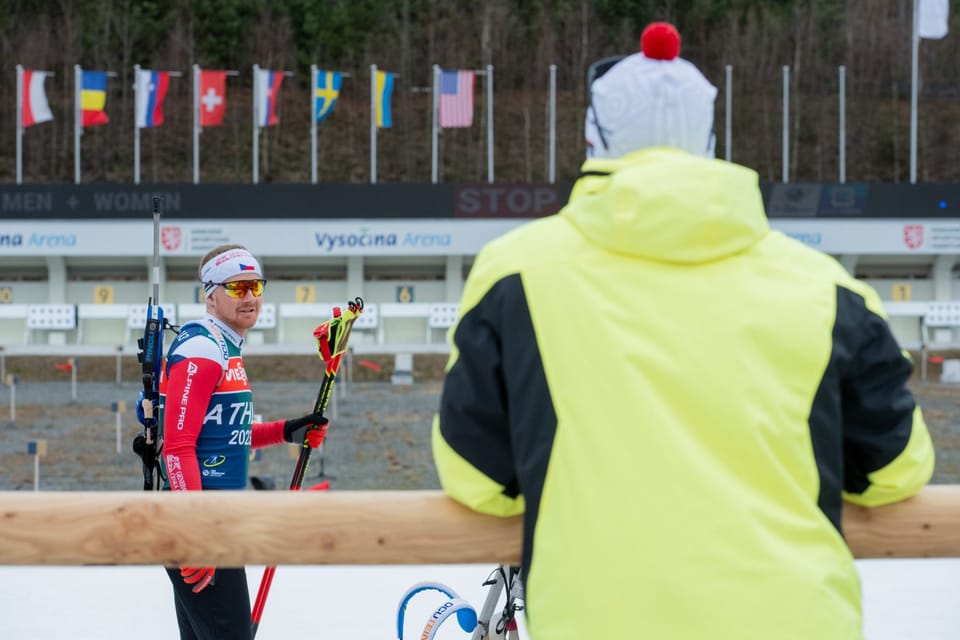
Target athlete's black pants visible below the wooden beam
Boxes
[167,567,253,640]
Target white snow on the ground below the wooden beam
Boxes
[0,559,960,640]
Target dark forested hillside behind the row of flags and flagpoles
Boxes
[0,0,960,183]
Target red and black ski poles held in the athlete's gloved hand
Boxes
[251,298,363,637]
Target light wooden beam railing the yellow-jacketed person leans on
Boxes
[0,485,960,566]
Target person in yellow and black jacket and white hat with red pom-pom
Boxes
[433,23,933,640]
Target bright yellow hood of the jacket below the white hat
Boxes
[560,147,770,263]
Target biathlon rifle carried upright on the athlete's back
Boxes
[133,196,174,491]
